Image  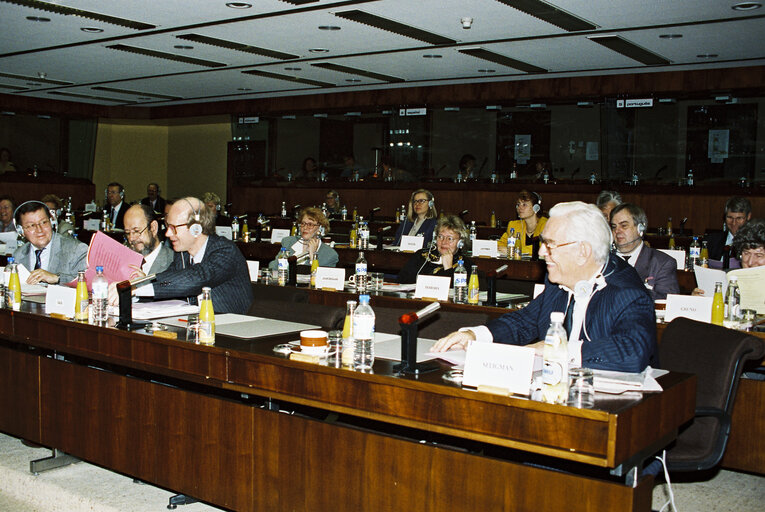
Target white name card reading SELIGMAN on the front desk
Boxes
[462,343,535,395]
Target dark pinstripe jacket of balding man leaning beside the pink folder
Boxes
[154,235,252,314]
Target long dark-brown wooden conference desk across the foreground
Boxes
[0,303,696,511]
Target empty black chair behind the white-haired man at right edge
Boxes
[659,318,765,471]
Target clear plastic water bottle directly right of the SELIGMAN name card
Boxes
[542,311,568,404]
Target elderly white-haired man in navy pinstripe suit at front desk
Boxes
[433,201,658,372]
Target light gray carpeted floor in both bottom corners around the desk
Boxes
[0,434,765,512]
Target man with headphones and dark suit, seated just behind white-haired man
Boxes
[611,203,680,300]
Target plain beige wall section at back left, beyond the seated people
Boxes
[93,116,231,206]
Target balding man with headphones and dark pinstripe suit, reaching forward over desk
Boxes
[109,197,252,313]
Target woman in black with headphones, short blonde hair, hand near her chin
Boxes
[398,215,471,283]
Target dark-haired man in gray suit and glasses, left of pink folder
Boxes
[13,201,88,284]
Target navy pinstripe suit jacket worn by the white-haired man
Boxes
[487,254,658,372]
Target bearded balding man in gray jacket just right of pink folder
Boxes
[125,204,173,275]
